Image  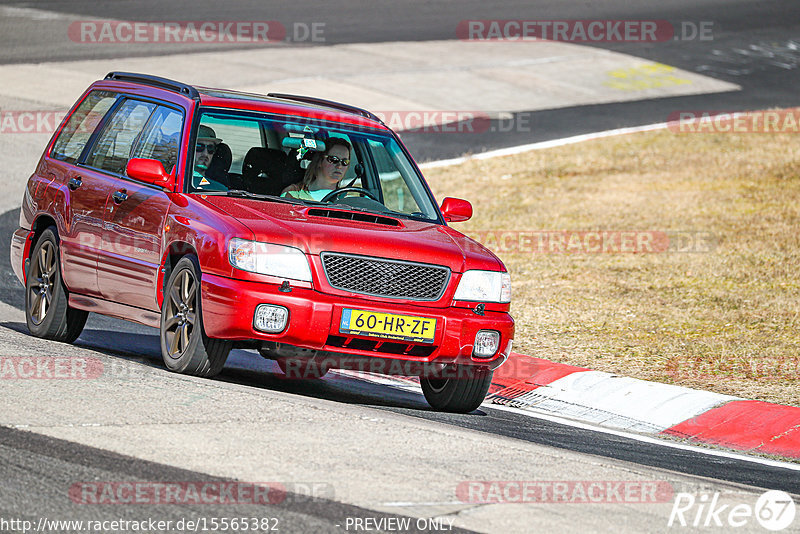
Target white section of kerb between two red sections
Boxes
[506,371,742,433]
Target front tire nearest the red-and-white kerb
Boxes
[419,365,494,413]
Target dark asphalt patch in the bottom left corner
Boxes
[0,427,470,533]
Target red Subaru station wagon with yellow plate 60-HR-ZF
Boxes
[11,72,514,412]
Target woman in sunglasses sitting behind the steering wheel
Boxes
[281,137,350,201]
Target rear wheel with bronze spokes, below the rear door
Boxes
[25,226,89,343]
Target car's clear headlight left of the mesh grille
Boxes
[228,238,311,282]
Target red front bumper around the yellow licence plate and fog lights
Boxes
[202,274,514,368]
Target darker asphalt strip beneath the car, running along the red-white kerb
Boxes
[0,210,800,502]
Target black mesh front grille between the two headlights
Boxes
[320,252,450,300]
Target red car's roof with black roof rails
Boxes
[95,71,388,130]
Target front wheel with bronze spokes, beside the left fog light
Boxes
[159,256,232,377]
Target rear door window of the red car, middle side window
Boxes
[86,100,156,174]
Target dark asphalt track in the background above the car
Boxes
[0,0,800,161]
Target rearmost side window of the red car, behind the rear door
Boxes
[50,91,117,163]
